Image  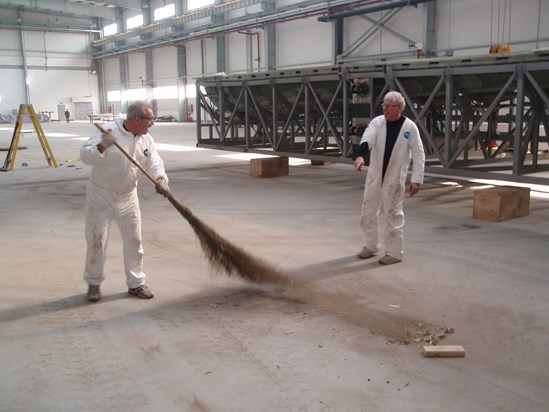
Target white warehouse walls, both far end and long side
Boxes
[0,0,549,120]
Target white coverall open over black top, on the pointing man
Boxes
[360,116,425,259]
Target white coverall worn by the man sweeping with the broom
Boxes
[80,119,168,288]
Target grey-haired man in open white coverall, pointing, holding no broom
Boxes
[354,91,425,265]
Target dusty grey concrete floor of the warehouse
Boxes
[0,123,549,412]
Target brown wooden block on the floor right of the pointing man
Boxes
[473,186,530,222]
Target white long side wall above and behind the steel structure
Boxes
[94,0,549,120]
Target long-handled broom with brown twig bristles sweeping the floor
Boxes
[94,123,293,284]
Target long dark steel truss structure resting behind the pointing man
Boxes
[196,50,549,184]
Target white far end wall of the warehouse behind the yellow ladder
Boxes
[0,10,99,120]
